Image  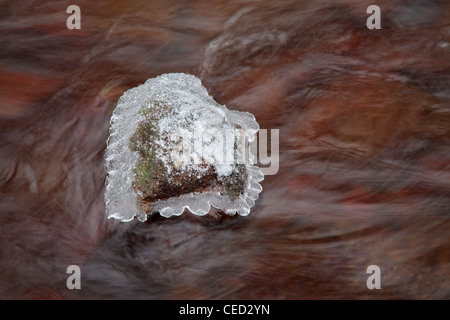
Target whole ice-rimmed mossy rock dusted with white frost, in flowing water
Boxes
[105,73,264,221]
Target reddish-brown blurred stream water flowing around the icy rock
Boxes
[0,0,450,299]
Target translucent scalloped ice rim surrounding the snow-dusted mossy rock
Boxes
[104,73,264,222]
